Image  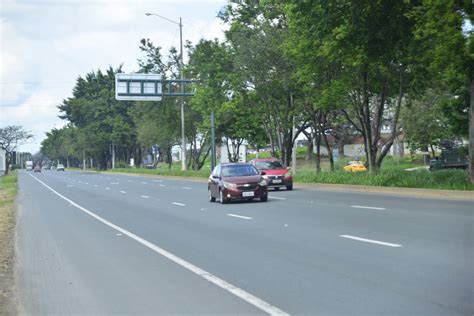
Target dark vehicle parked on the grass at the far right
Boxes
[430,141,469,171]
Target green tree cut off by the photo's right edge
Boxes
[410,0,474,183]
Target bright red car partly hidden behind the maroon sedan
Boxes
[250,158,293,190]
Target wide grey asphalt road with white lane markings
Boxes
[16,171,474,315]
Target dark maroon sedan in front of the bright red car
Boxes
[207,163,268,204]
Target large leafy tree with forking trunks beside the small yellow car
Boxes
[283,0,414,172]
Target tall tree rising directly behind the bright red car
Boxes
[221,1,301,165]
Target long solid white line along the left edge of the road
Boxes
[28,174,289,315]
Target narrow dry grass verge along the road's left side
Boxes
[0,171,17,315]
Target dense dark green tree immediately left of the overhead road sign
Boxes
[58,67,136,169]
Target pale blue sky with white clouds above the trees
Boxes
[0,0,227,153]
